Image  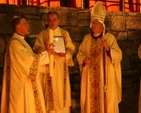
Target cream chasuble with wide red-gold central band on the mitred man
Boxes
[77,33,122,113]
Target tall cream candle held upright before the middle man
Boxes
[49,29,54,76]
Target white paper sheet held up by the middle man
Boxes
[54,36,66,53]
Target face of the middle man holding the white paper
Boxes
[47,14,60,30]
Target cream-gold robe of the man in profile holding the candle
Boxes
[1,33,49,113]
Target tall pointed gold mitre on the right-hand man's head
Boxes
[90,1,106,27]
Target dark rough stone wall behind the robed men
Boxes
[0,4,141,113]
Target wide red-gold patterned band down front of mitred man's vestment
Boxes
[90,38,101,113]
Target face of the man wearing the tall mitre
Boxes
[91,20,103,34]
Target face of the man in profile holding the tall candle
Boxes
[17,18,29,36]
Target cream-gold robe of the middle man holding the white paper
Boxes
[33,27,75,113]
